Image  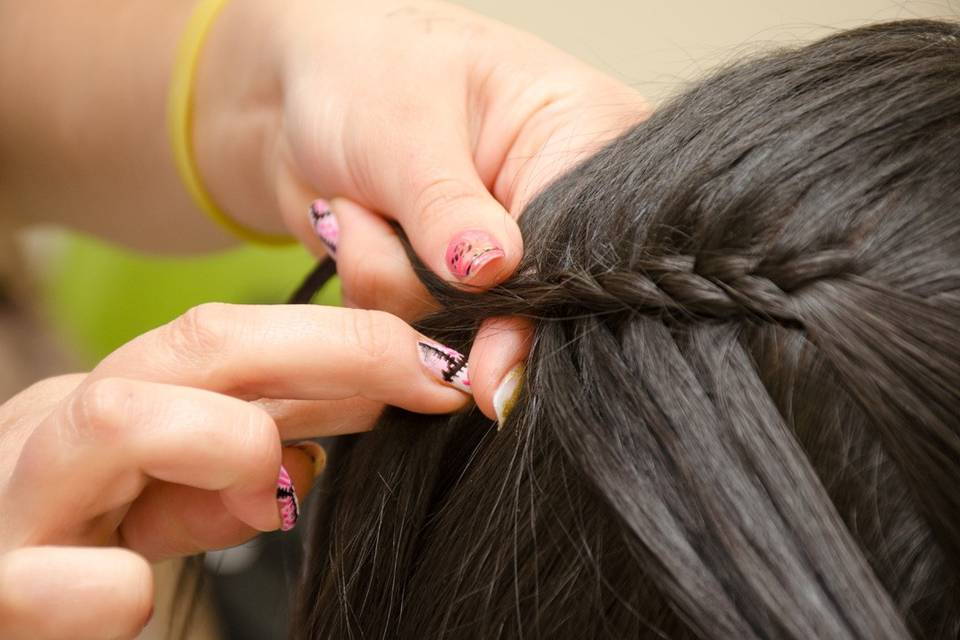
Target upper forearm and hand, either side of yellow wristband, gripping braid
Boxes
[0,0,648,430]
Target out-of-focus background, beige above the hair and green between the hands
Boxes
[0,0,960,639]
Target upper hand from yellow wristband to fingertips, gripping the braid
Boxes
[192,0,649,417]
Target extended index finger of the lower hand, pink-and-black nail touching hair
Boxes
[88,303,470,413]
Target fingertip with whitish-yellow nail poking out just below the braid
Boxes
[470,317,533,422]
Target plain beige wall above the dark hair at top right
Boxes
[458,0,960,99]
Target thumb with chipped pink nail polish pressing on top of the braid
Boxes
[390,143,523,289]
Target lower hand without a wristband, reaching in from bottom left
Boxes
[0,304,469,639]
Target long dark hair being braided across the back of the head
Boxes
[293,21,960,640]
